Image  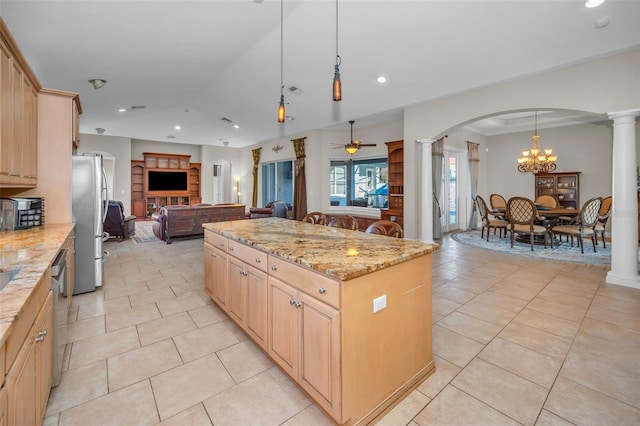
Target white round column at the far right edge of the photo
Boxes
[606,110,640,289]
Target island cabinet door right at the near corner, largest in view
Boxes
[298,293,341,418]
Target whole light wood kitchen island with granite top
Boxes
[204,218,438,424]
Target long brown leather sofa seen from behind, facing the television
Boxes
[151,203,245,244]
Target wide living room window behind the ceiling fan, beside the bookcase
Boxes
[329,158,388,209]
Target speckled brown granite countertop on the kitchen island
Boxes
[203,218,439,281]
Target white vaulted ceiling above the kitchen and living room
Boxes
[0,0,640,147]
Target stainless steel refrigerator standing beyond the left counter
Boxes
[71,153,109,294]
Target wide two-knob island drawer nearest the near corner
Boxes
[269,256,340,308]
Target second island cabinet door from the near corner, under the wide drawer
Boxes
[267,277,299,378]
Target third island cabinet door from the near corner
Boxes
[245,265,267,350]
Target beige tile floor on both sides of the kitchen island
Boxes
[45,231,640,426]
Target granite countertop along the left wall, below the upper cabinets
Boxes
[0,223,74,345]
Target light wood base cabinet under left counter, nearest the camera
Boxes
[6,292,53,425]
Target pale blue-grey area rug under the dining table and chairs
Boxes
[451,231,636,265]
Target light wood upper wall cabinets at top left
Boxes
[0,19,41,188]
